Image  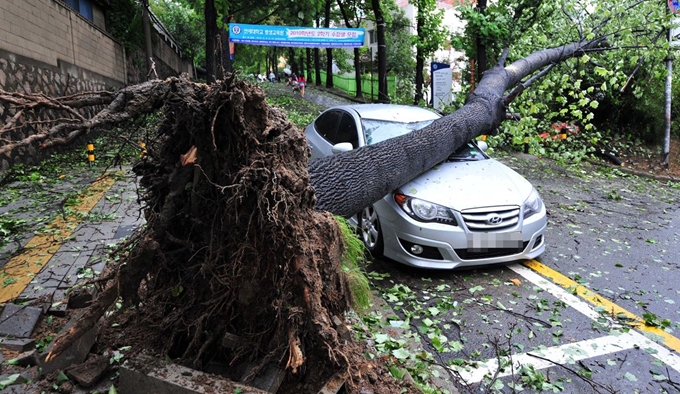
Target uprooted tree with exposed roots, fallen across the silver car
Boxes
[0,39,628,393]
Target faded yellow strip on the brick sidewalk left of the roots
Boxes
[0,174,116,303]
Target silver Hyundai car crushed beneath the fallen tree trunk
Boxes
[305,104,547,269]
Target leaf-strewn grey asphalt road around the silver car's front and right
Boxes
[370,154,680,393]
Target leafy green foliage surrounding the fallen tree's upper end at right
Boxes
[452,0,668,163]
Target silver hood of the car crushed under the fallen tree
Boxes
[399,159,532,211]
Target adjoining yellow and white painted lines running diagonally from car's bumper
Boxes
[508,260,680,372]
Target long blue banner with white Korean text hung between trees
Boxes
[229,23,365,48]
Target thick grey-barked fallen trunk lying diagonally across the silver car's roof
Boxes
[309,40,601,217]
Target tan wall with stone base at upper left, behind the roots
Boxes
[0,0,193,172]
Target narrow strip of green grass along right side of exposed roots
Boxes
[336,216,372,313]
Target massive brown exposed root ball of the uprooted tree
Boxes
[45,78,418,393]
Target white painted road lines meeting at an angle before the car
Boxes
[451,264,680,384]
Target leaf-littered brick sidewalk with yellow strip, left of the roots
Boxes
[0,168,144,342]
